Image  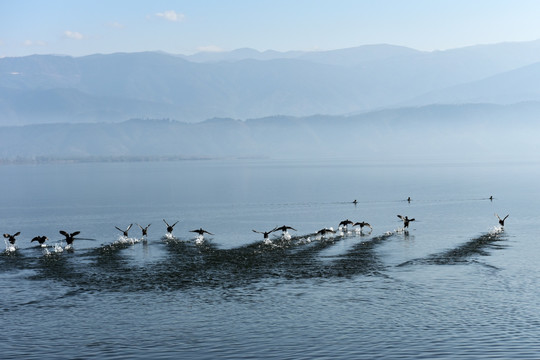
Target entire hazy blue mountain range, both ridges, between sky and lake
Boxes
[0,41,540,159]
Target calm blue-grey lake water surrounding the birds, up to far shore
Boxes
[0,160,540,359]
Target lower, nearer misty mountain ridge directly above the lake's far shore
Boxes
[0,102,540,163]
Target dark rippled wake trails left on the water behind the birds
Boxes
[0,228,510,291]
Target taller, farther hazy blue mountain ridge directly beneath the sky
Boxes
[0,41,540,125]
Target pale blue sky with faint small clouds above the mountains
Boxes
[0,0,540,57]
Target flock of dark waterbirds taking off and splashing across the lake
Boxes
[4,196,509,249]
